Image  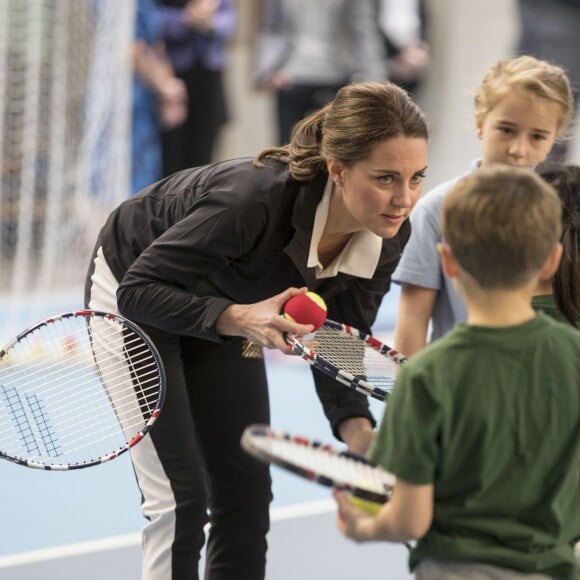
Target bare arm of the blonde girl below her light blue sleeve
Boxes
[394,284,437,357]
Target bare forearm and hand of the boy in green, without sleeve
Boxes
[334,479,433,542]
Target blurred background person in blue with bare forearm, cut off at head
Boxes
[131,0,187,194]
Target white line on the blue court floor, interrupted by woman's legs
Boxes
[0,499,336,569]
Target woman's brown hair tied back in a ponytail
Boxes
[254,82,429,181]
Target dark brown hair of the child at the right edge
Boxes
[537,163,580,328]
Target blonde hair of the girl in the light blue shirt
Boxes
[475,55,574,137]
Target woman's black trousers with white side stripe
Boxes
[134,326,271,580]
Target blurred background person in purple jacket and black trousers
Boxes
[161,0,236,176]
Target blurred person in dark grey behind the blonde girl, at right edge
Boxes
[516,0,580,162]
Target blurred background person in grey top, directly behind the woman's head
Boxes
[255,0,387,145]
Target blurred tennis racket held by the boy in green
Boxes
[241,425,395,513]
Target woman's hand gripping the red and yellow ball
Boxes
[216,288,314,354]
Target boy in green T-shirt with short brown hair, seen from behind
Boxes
[335,166,580,580]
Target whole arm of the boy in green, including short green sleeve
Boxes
[334,352,443,542]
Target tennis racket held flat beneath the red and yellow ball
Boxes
[285,320,407,401]
